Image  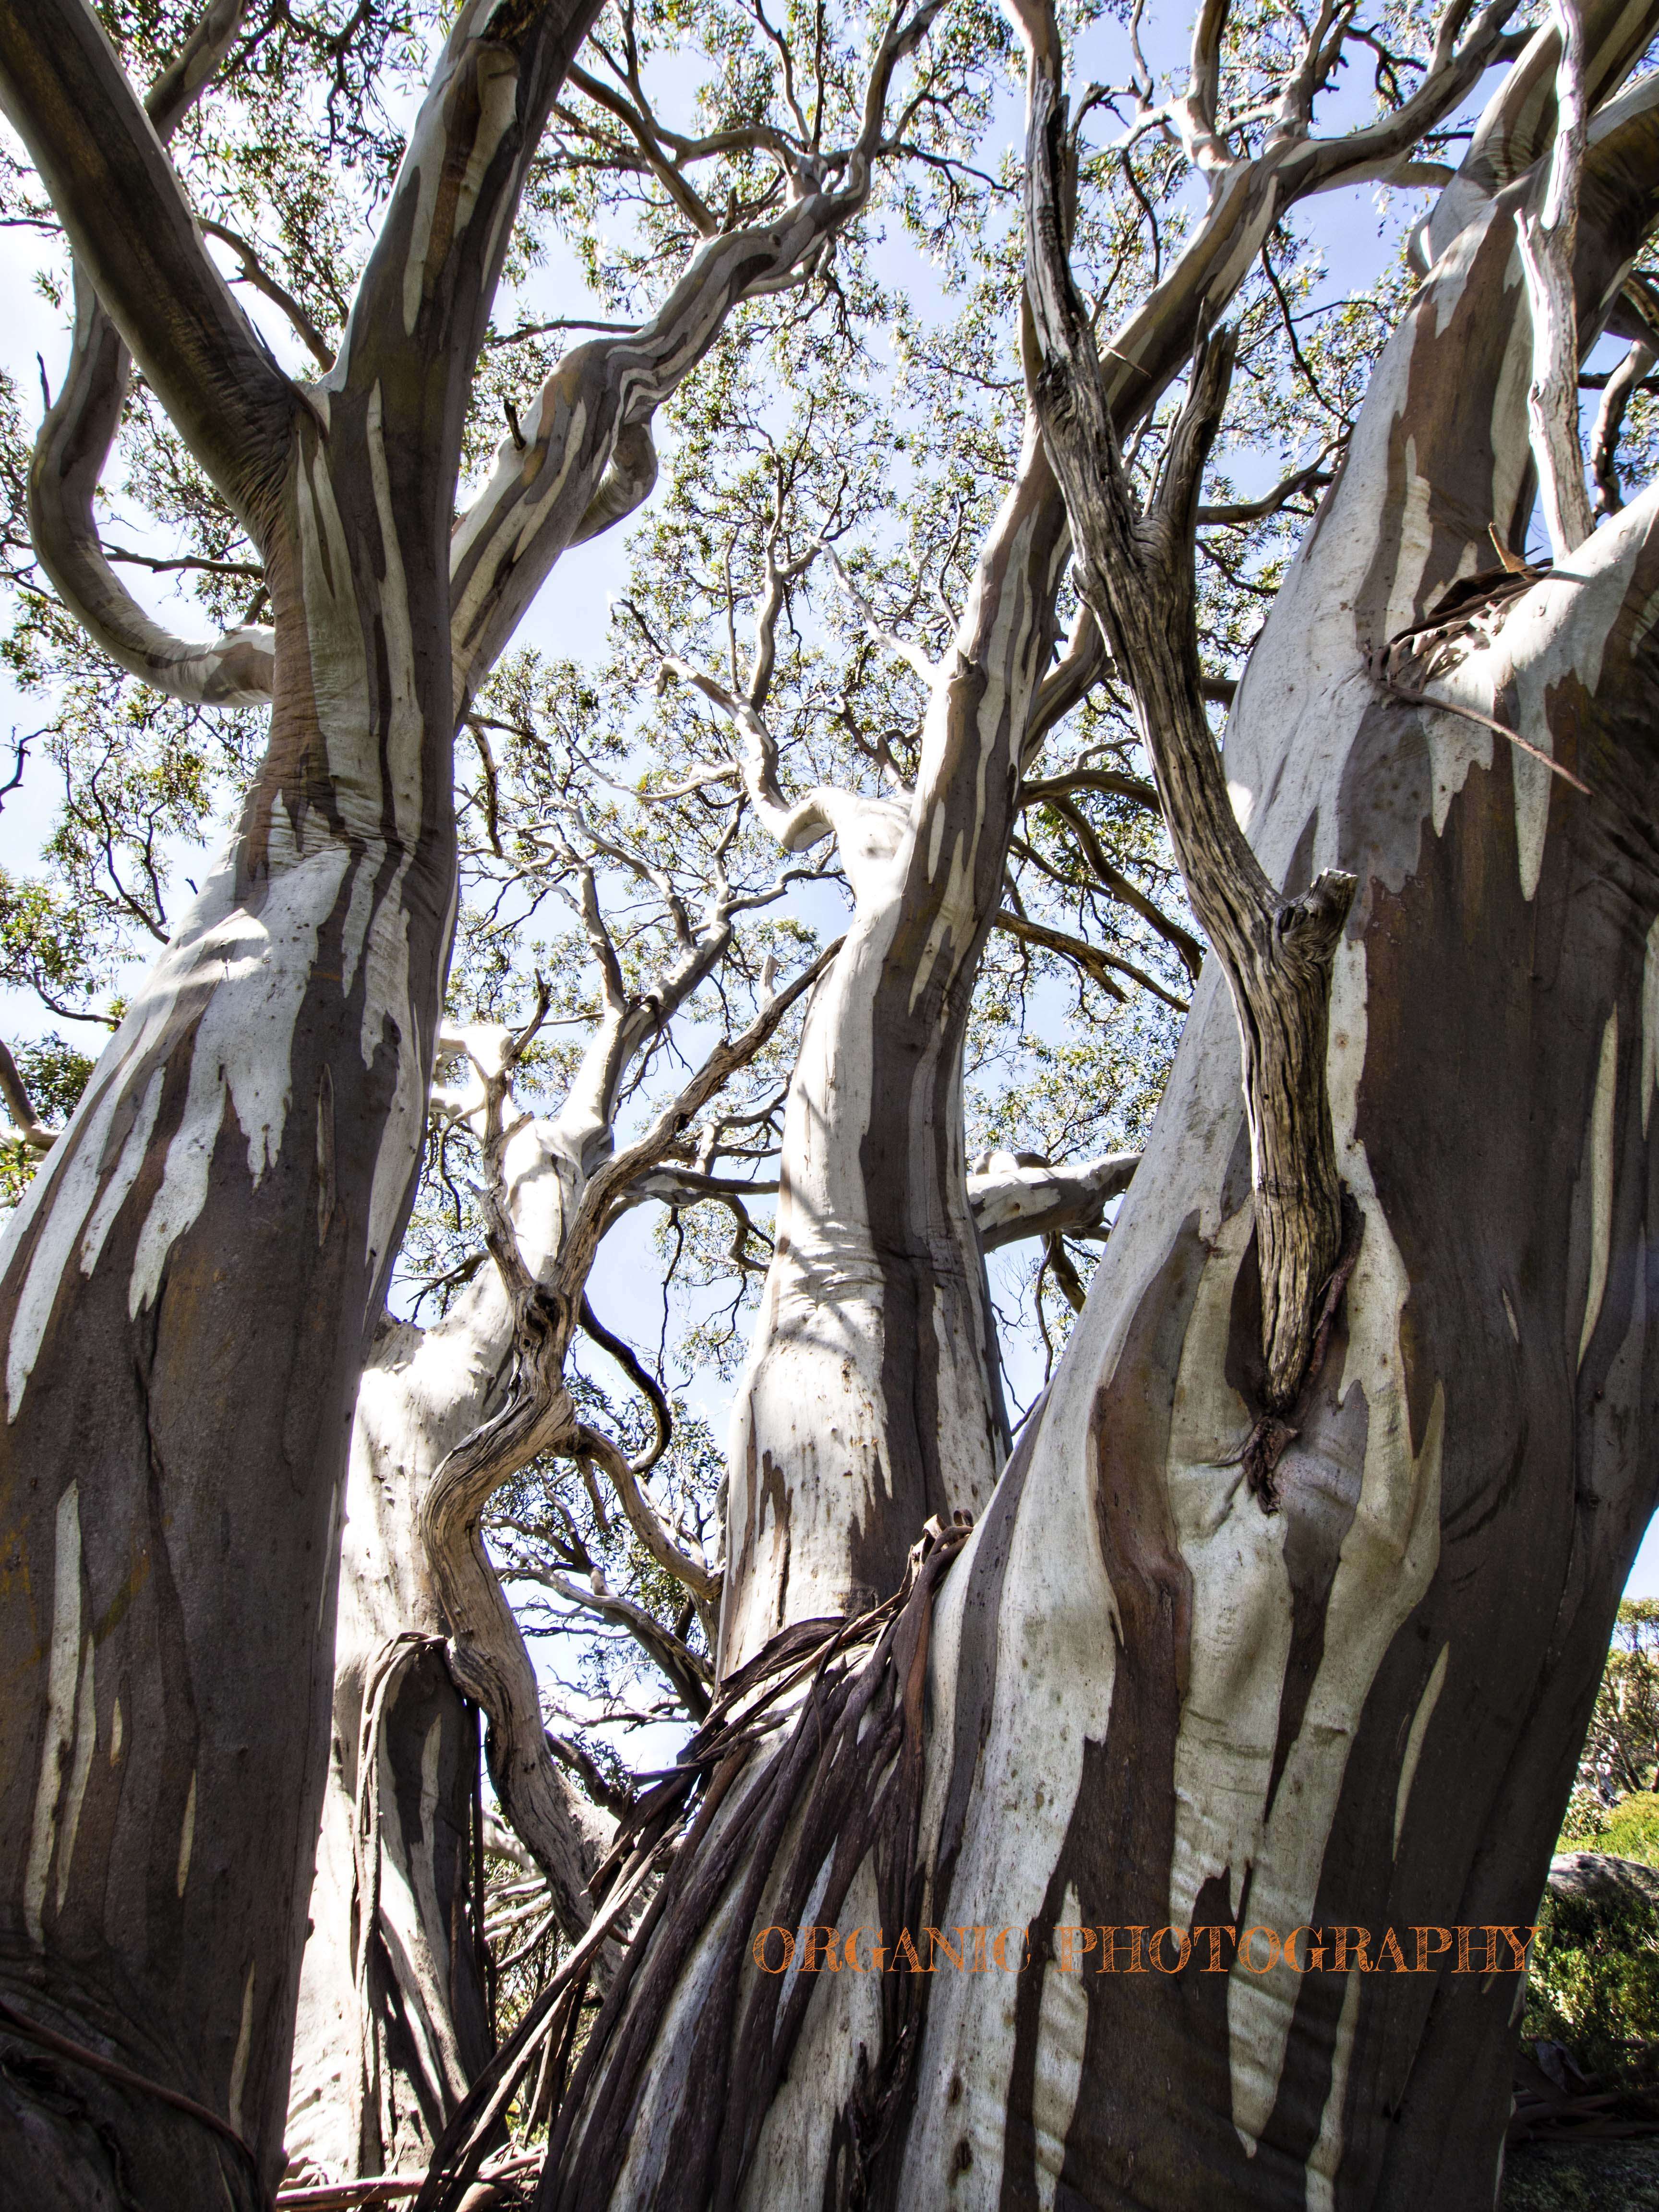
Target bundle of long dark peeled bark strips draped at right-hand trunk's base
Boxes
[416,1522,969,2212]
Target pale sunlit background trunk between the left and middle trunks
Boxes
[288,1044,611,2181]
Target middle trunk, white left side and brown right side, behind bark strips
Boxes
[719,416,1069,1672]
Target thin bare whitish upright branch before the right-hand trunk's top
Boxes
[1515,0,1595,562]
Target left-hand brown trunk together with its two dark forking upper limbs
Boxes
[0,0,606,2205]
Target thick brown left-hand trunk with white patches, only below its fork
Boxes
[0,389,454,2203]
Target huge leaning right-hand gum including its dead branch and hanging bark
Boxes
[511,9,1659,2208]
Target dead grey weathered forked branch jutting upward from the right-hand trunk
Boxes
[1015,7,1354,1416]
